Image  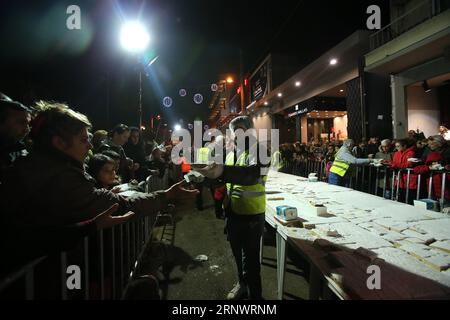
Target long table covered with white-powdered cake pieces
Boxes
[266,171,450,299]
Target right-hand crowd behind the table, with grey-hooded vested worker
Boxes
[280,130,450,204]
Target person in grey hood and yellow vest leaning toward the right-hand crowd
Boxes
[328,139,373,187]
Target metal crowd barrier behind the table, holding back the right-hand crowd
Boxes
[281,160,450,210]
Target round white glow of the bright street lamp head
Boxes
[120,21,150,52]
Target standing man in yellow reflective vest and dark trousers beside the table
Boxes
[222,117,270,300]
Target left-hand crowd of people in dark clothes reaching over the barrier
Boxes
[0,94,198,298]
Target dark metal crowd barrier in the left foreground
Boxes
[0,211,151,300]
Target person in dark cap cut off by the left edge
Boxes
[0,94,31,181]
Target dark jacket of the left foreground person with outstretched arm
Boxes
[0,151,166,227]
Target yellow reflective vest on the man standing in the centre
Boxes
[224,151,267,215]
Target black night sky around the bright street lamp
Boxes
[0,0,388,129]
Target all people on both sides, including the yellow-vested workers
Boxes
[0,94,450,299]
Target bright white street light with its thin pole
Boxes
[120,21,150,128]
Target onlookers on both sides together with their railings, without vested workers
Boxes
[0,95,450,299]
